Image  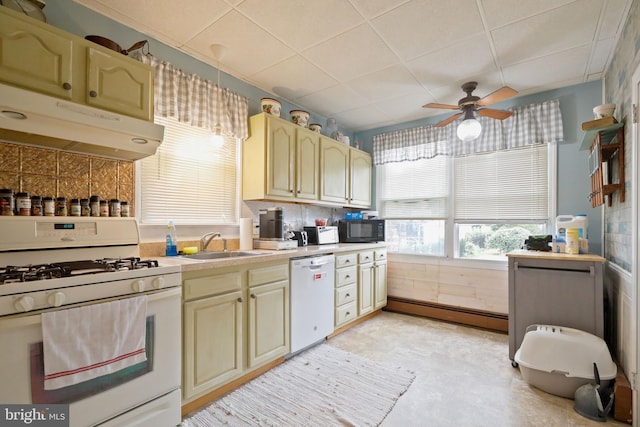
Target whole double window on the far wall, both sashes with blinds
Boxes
[376,144,555,260]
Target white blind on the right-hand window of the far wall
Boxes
[454,144,549,222]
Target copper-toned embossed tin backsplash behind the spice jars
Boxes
[0,141,135,216]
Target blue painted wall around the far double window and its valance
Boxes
[355,80,602,254]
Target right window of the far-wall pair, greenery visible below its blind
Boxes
[454,144,549,259]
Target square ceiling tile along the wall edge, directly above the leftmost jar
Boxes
[250,55,338,99]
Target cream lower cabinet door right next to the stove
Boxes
[182,291,243,399]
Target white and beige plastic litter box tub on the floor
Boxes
[514,325,617,399]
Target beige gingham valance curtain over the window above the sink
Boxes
[131,51,249,140]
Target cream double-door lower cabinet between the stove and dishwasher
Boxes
[182,260,289,403]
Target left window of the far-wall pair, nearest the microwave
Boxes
[377,156,451,256]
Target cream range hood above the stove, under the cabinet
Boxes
[0,84,164,160]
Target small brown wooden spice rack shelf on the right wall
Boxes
[581,123,625,208]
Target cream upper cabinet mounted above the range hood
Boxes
[0,7,153,121]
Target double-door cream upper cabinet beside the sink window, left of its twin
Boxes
[242,113,320,201]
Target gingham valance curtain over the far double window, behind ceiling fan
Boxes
[373,99,564,165]
